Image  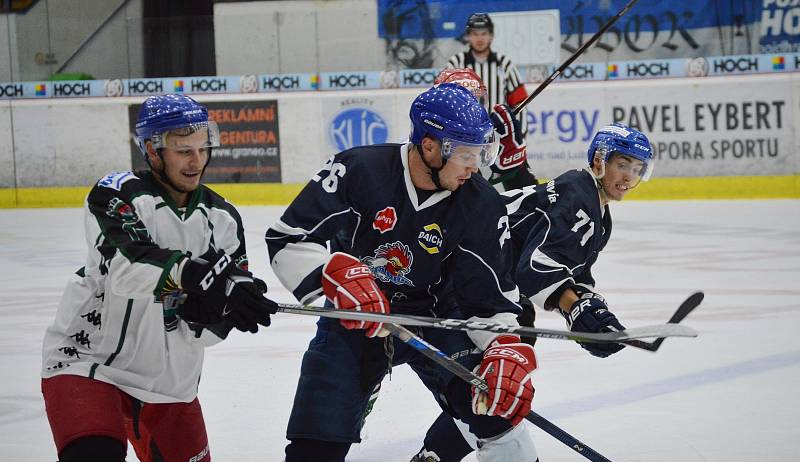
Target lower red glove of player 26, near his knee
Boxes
[472,335,536,425]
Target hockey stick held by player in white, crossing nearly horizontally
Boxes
[278,303,697,343]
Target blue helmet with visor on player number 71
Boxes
[588,122,654,181]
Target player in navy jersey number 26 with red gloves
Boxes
[266,84,536,462]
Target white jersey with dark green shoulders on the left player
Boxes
[42,172,247,403]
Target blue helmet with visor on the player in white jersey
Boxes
[136,93,220,158]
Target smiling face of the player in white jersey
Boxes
[150,130,209,204]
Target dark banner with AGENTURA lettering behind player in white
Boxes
[129,100,281,183]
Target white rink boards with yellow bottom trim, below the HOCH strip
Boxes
[0,73,800,207]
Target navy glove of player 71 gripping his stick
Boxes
[564,292,625,358]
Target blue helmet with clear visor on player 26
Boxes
[409,83,500,167]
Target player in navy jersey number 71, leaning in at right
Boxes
[413,123,654,462]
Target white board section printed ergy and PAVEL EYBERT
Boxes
[527,76,796,177]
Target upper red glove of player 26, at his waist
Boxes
[322,252,389,337]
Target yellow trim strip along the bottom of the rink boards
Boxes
[0,175,800,208]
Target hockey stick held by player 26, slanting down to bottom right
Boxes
[383,324,611,462]
